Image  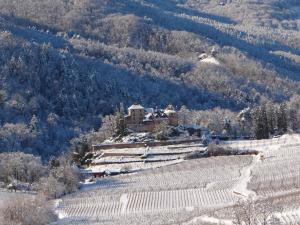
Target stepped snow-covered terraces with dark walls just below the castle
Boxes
[86,142,205,176]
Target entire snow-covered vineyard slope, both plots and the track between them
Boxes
[57,135,300,224]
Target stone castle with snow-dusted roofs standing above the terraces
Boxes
[124,104,179,132]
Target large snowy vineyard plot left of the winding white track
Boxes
[58,156,252,222]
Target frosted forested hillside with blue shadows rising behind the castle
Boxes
[0,0,300,157]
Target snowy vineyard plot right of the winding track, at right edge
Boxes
[249,143,300,196]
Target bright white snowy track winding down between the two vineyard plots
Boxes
[233,154,260,198]
